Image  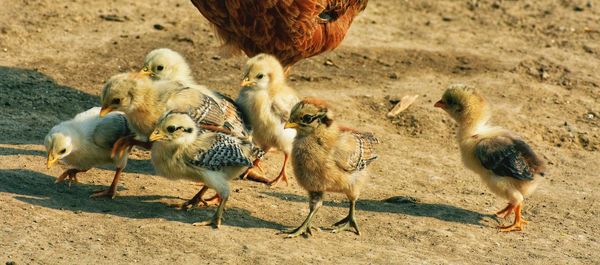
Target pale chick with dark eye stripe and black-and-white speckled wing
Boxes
[149,111,264,228]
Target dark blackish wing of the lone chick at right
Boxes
[475,135,543,180]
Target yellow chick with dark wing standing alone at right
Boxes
[434,84,545,232]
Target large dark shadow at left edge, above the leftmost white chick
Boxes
[0,66,99,144]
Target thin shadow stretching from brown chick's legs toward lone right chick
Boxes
[263,192,495,226]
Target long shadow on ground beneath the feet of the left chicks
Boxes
[0,169,283,229]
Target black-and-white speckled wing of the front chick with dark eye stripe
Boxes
[187,133,264,171]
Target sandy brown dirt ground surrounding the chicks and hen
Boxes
[0,0,600,264]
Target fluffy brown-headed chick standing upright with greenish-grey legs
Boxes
[284,98,379,237]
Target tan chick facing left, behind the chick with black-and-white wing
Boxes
[100,73,269,204]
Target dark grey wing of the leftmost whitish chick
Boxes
[92,112,132,149]
